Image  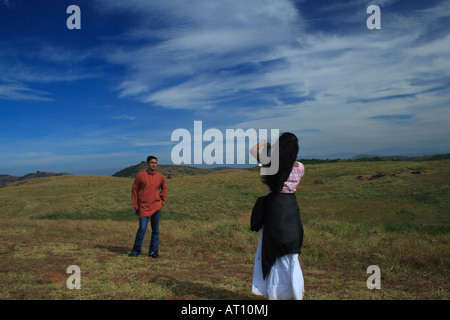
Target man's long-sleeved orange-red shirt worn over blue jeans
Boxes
[131,171,167,217]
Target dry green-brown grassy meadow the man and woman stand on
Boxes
[0,160,450,300]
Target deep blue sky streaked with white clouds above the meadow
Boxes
[0,0,450,175]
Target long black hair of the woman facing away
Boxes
[262,132,299,192]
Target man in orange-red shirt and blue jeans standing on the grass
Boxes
[128,156,167,258]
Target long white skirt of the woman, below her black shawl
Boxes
[252,229,305,300]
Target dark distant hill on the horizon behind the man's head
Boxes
[112,161,230,179]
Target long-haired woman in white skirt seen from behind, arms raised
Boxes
[251,133,305,300]
